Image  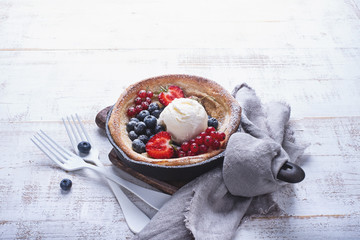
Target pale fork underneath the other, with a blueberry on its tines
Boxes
[62,114,155,233]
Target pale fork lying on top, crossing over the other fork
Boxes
[31,130,171,221]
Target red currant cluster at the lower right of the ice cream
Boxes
[176,127,226,157]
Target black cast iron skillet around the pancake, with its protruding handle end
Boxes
[105,107,305,183]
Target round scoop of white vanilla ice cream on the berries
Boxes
[159,98,208,143]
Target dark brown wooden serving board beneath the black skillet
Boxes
[95,106,187,195]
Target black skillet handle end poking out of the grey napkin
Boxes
[277,162,305,183]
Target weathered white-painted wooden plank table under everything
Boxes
[0,0,360,239]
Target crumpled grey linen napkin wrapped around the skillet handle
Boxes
[134,84,306,240]
